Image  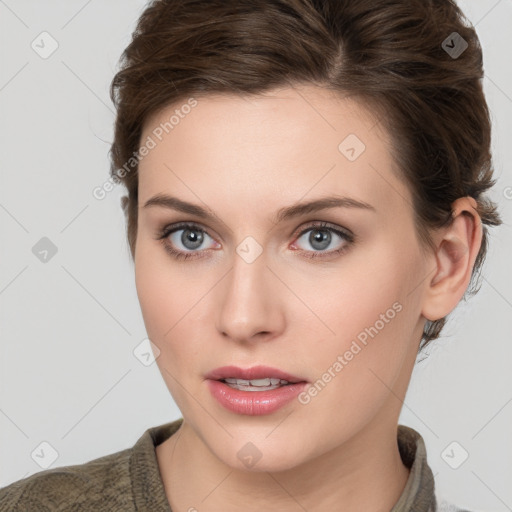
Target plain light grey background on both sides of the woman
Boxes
[0,0,512,512]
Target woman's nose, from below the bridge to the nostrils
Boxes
[216,247,286,343]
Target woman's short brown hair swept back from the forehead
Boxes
[110,0,501,348]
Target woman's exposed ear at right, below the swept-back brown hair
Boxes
[422,197,482,321]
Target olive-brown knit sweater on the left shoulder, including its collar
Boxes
[0,418,183,512]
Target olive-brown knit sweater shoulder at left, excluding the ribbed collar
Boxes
[0,442,132,512]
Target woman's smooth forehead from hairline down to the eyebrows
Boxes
[139,86,408,220]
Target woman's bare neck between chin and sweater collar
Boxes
[156,412,409,512]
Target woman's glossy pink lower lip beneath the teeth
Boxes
[208,379,307,416]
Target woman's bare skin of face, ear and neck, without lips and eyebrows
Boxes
[134,86,482,512]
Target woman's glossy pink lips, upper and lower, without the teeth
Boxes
[206,366,308,416]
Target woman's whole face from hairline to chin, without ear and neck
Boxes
[135,86,432,471]
